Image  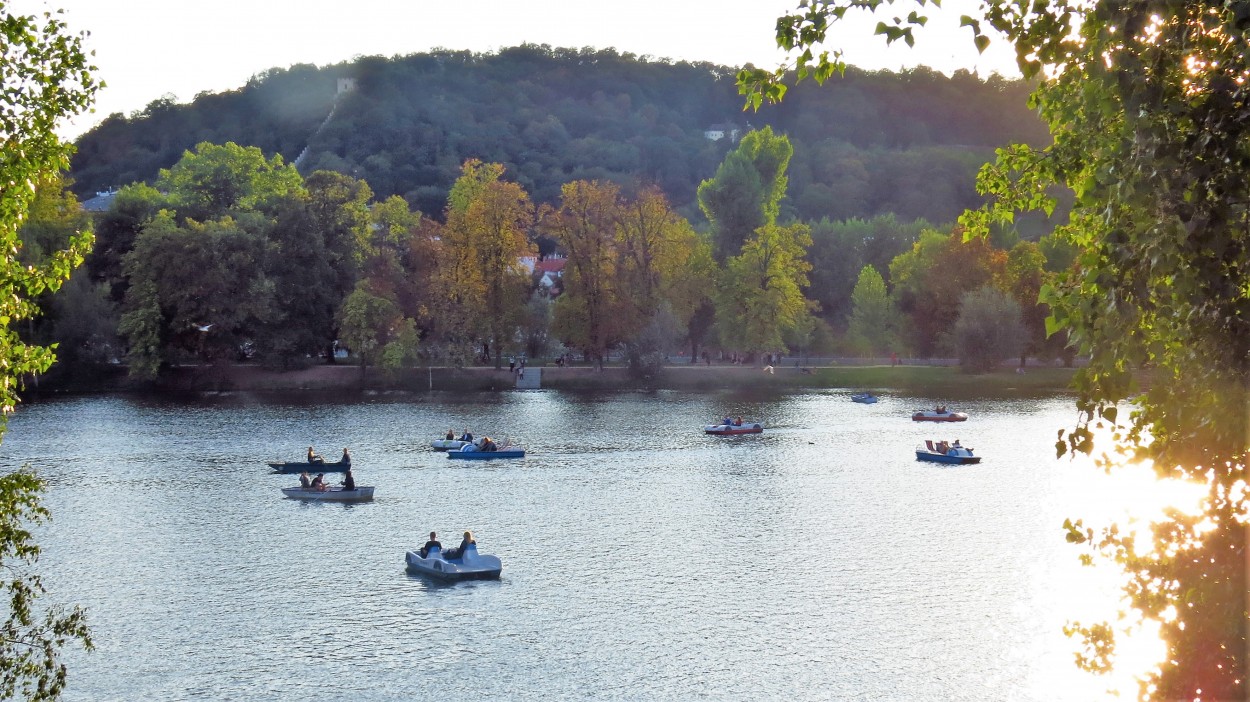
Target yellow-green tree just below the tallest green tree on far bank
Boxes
[716,224,811,353]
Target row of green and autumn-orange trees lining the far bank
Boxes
[23,129,1070,378]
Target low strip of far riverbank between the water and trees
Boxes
[28,357,1074,396]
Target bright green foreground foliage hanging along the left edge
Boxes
[0,0,100,700]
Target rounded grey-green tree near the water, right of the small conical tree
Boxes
[951,286,1025,372]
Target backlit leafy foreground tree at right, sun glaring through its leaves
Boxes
[740,0,1250,700]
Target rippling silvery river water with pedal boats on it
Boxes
[0,391,1135,702]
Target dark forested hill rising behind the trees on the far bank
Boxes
[73,45,1046,221]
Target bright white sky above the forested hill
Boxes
[8,0,1016,136]
